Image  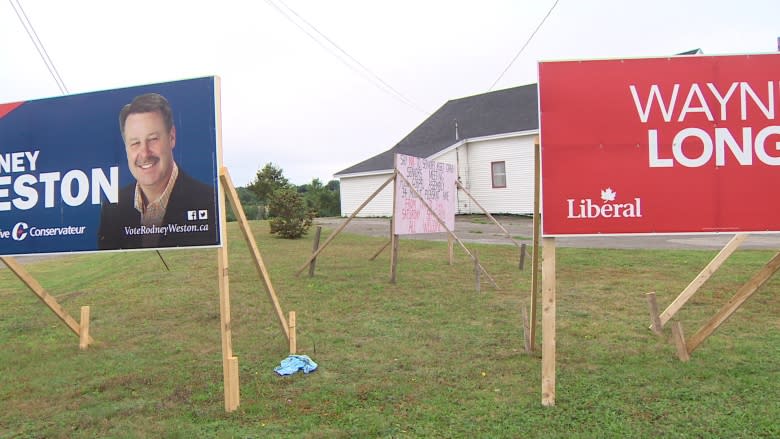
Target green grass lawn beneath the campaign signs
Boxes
[0,221,780,438]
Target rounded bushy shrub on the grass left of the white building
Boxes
[268,187,315,239]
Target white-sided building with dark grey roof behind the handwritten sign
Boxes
[335,84,539,217]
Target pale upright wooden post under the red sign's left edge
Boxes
[542,238,555,406]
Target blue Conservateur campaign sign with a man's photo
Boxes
[0,77,221,256]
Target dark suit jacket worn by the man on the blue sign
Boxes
[98,168,219,250]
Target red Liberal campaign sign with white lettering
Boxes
[539,54,780,236]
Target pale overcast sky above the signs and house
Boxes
[0,0,780,186]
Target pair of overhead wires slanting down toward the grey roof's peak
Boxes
[266,0,430,115]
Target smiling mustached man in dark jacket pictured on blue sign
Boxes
[98,93,218,250]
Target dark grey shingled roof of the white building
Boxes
[336,84,539,176]
